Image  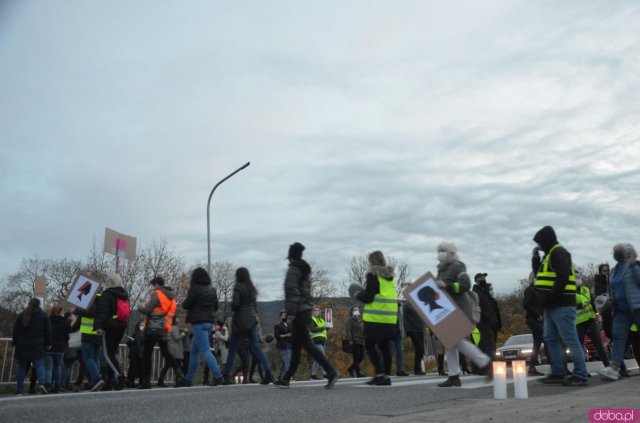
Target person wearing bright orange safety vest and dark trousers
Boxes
[138,276,187,389]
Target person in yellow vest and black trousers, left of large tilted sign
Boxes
[356,251,398,386]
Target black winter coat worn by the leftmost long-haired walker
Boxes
[11,307,51,360]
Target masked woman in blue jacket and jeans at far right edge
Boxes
[598,244,640,380]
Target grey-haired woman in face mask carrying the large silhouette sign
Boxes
[436,242,491,388]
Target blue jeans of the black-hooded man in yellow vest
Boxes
[544,306,587,380]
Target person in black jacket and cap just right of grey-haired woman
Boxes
[473,273,501,376]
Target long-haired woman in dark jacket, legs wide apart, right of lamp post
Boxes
[222,267,274,385]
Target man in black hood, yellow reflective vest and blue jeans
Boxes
[531,226,588,386]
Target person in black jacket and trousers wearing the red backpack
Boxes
[93,273,129,391]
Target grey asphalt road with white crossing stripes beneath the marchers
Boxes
[0,361,637,423]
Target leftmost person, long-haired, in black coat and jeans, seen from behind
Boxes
[11,298,52,395]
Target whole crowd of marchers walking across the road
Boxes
[12,226,640,395]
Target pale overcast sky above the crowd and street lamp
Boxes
[0,0,640,300]
